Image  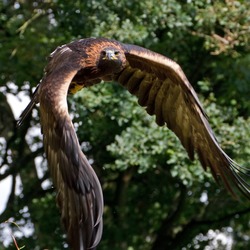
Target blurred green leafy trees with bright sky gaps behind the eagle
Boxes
[0,0,250,250]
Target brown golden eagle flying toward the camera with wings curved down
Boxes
[18,38,250,250]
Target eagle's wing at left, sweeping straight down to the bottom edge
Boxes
[19,45,103,250]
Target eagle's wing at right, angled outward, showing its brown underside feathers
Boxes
[115,44,250,198]
